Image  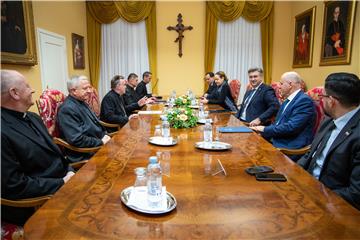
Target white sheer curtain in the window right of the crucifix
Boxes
[214,17,262,103]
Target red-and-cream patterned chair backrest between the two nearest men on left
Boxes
[36,89,66,137]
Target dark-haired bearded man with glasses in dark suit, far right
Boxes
[298,73,360,210]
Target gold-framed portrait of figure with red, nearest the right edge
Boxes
[320,1,356,66]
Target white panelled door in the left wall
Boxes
[37,28,68,95]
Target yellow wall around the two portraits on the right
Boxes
[272,2,360,89]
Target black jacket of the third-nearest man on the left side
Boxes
[100,90,129,126]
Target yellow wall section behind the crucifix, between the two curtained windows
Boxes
[156,1,205,95]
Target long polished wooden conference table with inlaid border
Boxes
[24,106,360,239]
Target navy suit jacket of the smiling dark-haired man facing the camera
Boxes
[236,83,279,124]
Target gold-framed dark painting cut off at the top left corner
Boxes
[1,1,37,65]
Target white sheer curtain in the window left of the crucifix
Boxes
[99,19,151,99]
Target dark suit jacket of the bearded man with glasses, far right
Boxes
[298,110,360,210]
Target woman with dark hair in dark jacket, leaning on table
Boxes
[201,71,237,111]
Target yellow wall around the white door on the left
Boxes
[1,1,89,111]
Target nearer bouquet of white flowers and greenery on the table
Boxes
[167,107,198,128]
